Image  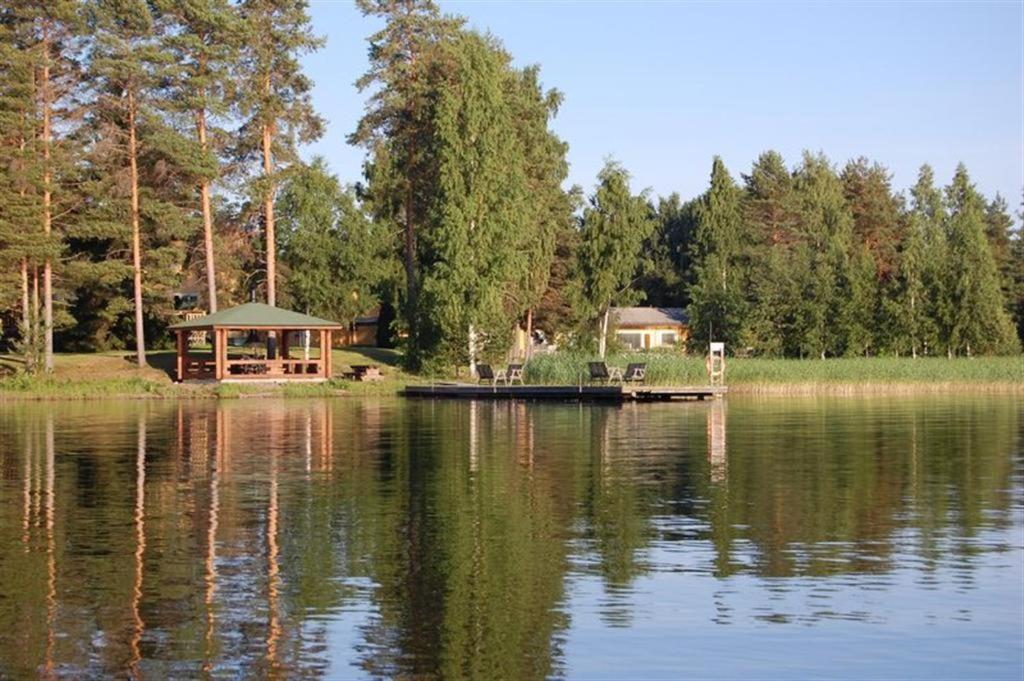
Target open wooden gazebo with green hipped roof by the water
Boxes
[170,303,343,382]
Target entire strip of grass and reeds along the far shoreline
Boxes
[0,348,1024,399]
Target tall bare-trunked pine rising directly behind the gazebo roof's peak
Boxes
[237,0,324,305]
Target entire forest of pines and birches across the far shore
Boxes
[0,0,1024,371]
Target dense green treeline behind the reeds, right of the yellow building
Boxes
[686,152,1024,357]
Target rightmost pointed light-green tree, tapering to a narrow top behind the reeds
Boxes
[945,164,1019,355]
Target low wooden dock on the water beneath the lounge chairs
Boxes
[399,383,727,402]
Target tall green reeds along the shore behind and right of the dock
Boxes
[526,353,1024,393]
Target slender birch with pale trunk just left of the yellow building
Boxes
[573,161,654,357]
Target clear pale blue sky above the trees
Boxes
[305,0,1024,212]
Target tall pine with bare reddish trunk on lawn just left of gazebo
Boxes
[83,0,194,360]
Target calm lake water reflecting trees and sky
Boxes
[0,396,1024,679]
